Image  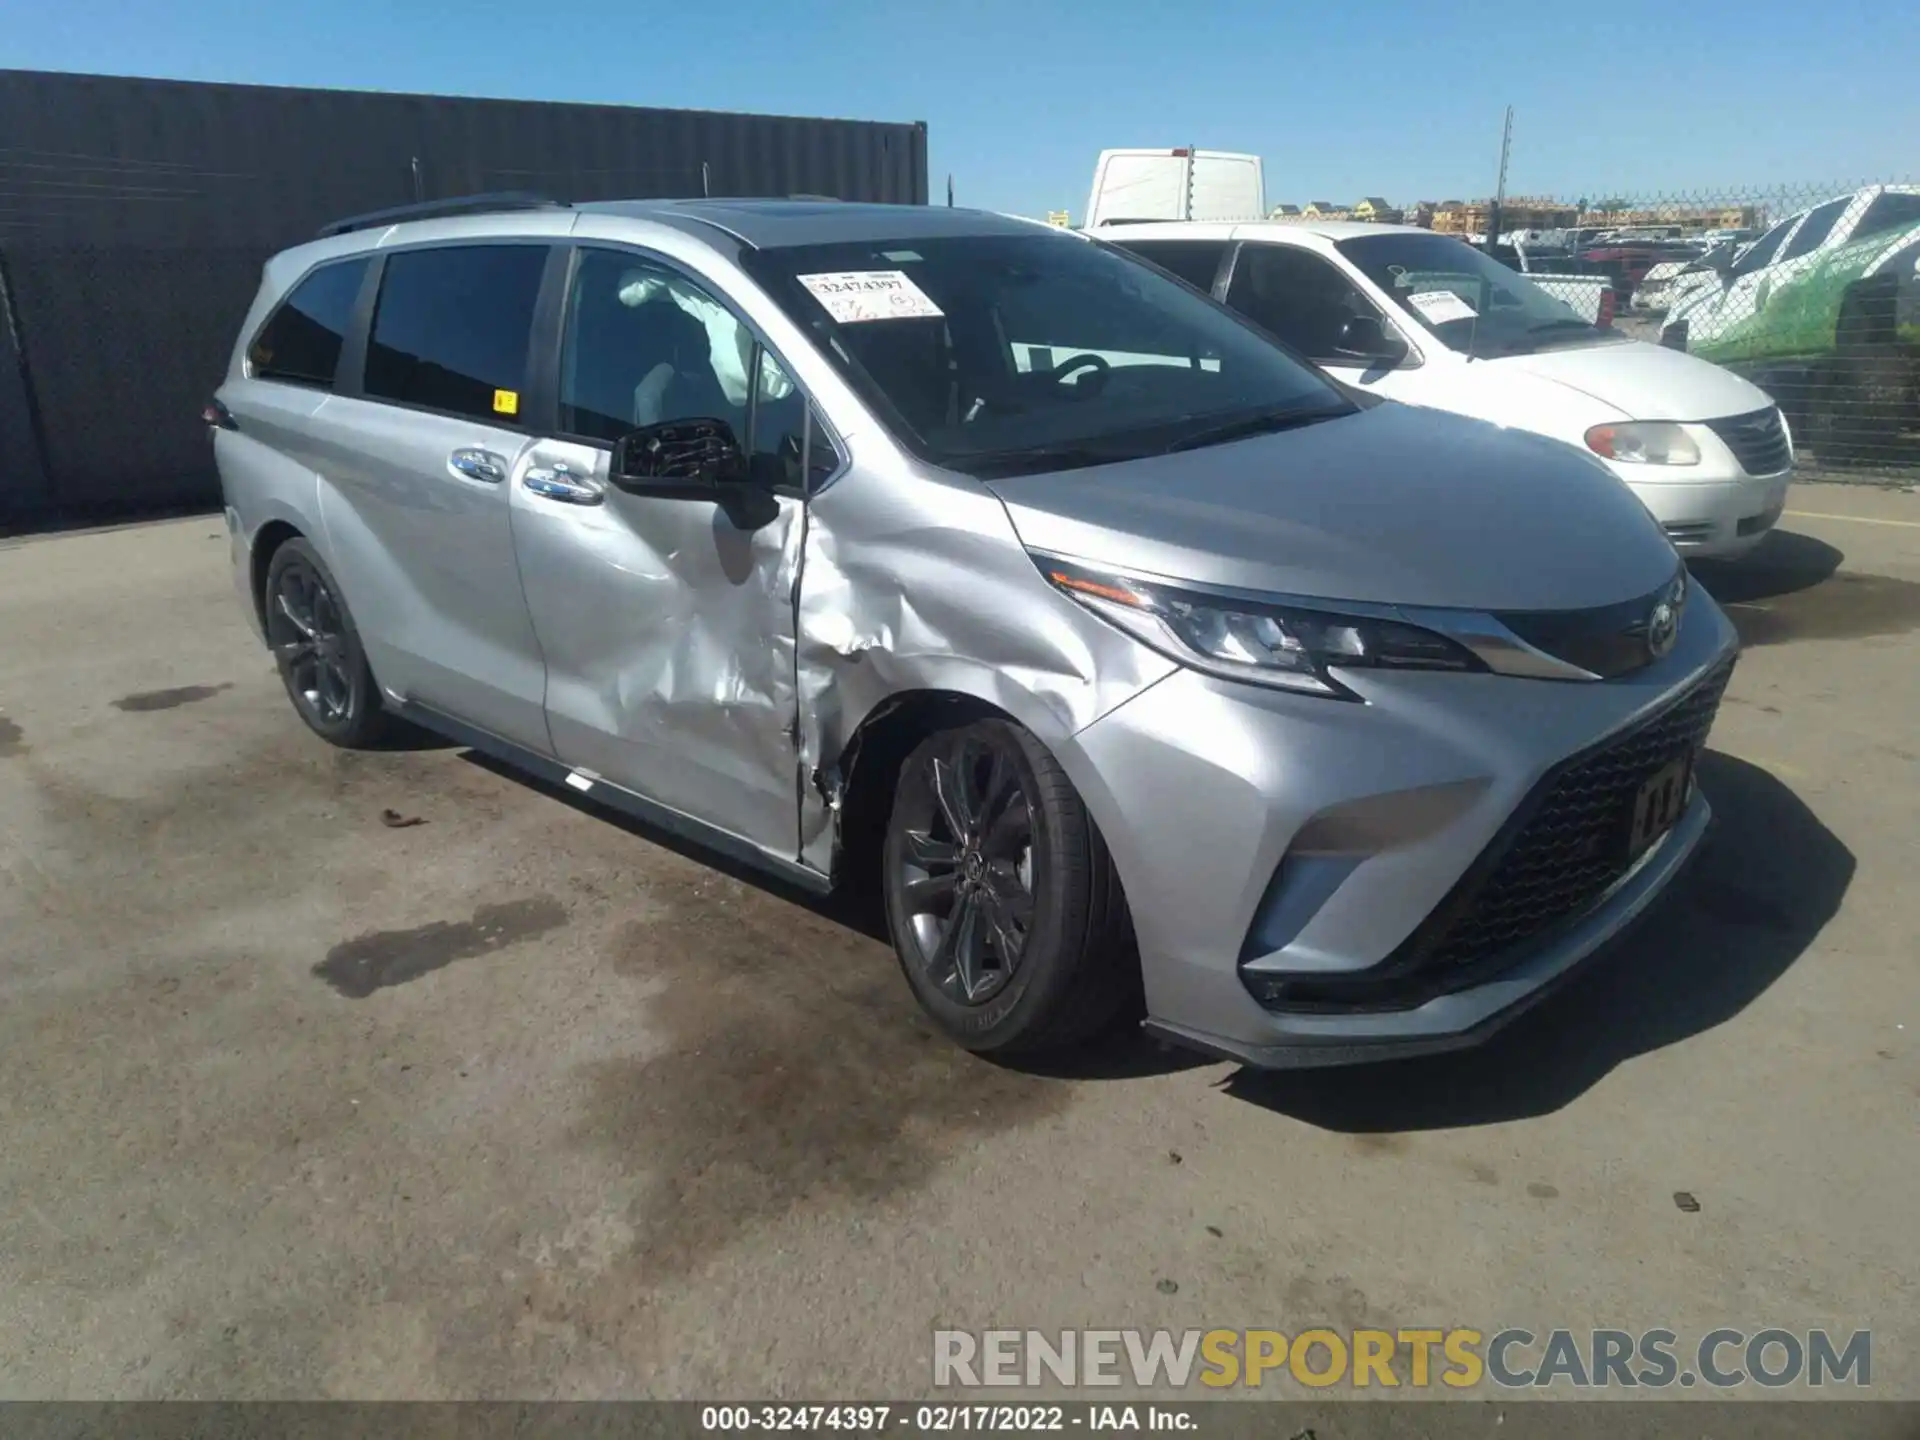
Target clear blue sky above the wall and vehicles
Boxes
[0,0,1920,219]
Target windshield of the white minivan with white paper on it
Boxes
[1338,234,1620,357]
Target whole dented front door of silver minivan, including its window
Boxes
[513,248,806,860]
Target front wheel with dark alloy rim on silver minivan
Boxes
[883,720,1139,1054]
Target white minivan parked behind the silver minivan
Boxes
[1102,223,1793,559]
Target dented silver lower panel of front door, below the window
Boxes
[513,440,803,858]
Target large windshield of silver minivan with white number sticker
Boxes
[741,232,1354,476]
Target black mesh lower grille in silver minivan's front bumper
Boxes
[1265,660,1734,1010]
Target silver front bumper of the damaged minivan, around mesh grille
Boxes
[1062,591,1736,1066]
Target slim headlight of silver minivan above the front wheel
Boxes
[1033,555,1486,699]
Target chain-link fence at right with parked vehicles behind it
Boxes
[1443,180,1920,484]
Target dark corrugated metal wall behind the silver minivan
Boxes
[0,71,927,518]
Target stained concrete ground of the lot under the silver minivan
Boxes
[0,488,1920,1398]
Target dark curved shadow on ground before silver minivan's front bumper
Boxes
[1227,753,1855,1133]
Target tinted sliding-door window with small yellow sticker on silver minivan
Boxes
[367,246,547,424]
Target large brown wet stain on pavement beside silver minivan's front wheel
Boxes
[549,872,1073,1323]
